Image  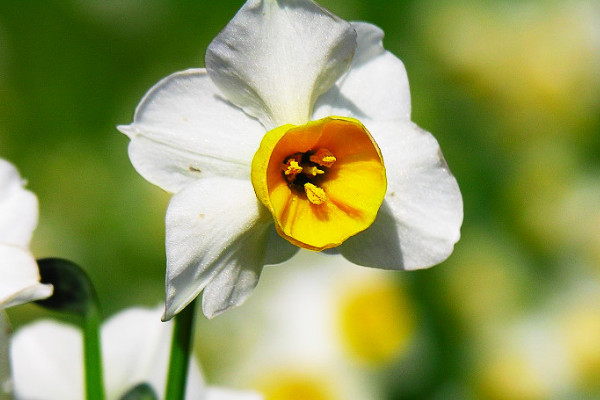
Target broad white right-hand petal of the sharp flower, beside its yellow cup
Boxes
[339,121,463,270]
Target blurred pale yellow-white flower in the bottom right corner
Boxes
[472,276,600,400]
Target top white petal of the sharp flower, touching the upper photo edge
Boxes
[206,0,356,129]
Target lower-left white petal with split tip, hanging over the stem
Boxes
[164,178,272,319]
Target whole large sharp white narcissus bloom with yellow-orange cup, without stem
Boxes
[119,0,462,319]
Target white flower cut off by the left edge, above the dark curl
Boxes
[0,159,52,310]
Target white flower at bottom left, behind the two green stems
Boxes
[10,307,261,400]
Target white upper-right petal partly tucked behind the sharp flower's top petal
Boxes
[313,22,410,120]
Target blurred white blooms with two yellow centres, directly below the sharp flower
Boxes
[197,250,416,400]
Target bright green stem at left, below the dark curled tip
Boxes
[83,305,104,400]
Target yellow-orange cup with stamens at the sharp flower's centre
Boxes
[252,117,387,251]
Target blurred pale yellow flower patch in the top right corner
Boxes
[417,0,600,144]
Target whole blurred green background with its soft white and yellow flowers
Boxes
[0,0,600,400]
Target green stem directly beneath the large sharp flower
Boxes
[165,300,196,400]
